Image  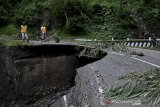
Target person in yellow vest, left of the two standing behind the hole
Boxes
[21,23,29,42]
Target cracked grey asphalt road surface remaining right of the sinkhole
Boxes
[50,49,160,107]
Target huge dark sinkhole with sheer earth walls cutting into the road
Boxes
[0,44,107,107]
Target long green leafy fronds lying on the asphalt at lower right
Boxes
[106,69,160,106]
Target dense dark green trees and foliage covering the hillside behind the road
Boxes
[0,0,160,39]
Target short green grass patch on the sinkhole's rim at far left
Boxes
[0,39,26,47]
